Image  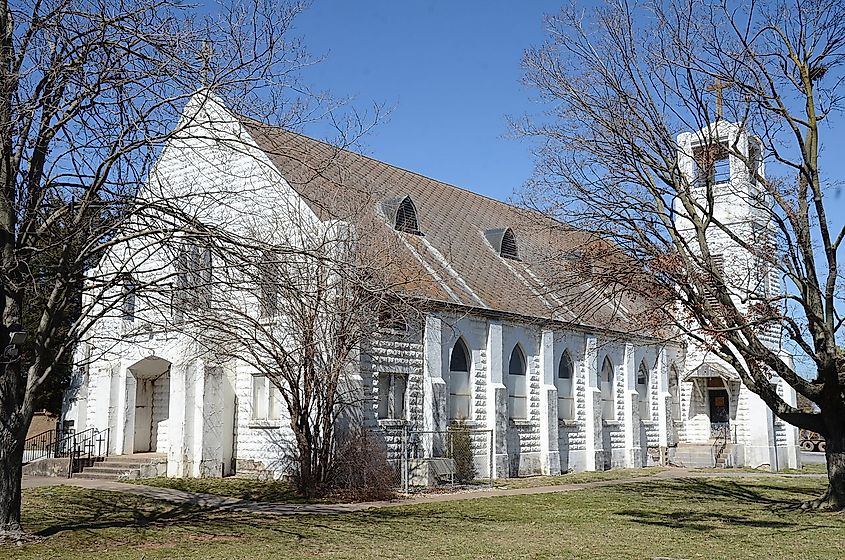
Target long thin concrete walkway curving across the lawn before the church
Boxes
[22,469,827,515]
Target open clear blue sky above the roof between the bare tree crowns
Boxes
[297,0,561,199]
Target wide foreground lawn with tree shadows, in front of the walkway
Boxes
[8,478,845,560]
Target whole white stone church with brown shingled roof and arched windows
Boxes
[63,94,800,478]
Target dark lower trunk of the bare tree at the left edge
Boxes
[0,418,26,538]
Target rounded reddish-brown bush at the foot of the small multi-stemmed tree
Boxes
[329,428,399,501]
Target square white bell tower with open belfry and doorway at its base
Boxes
[674,122,798,469]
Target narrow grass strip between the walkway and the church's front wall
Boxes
[122,477,330,504]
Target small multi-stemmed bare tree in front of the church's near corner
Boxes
[173,176,415,496]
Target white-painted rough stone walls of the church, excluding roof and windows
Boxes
[64,94,799,477]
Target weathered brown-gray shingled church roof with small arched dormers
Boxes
[243,120,656,331]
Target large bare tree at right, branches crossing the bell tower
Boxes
[517,0,845,508]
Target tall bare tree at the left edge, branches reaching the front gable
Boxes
[0,0,314,535]
